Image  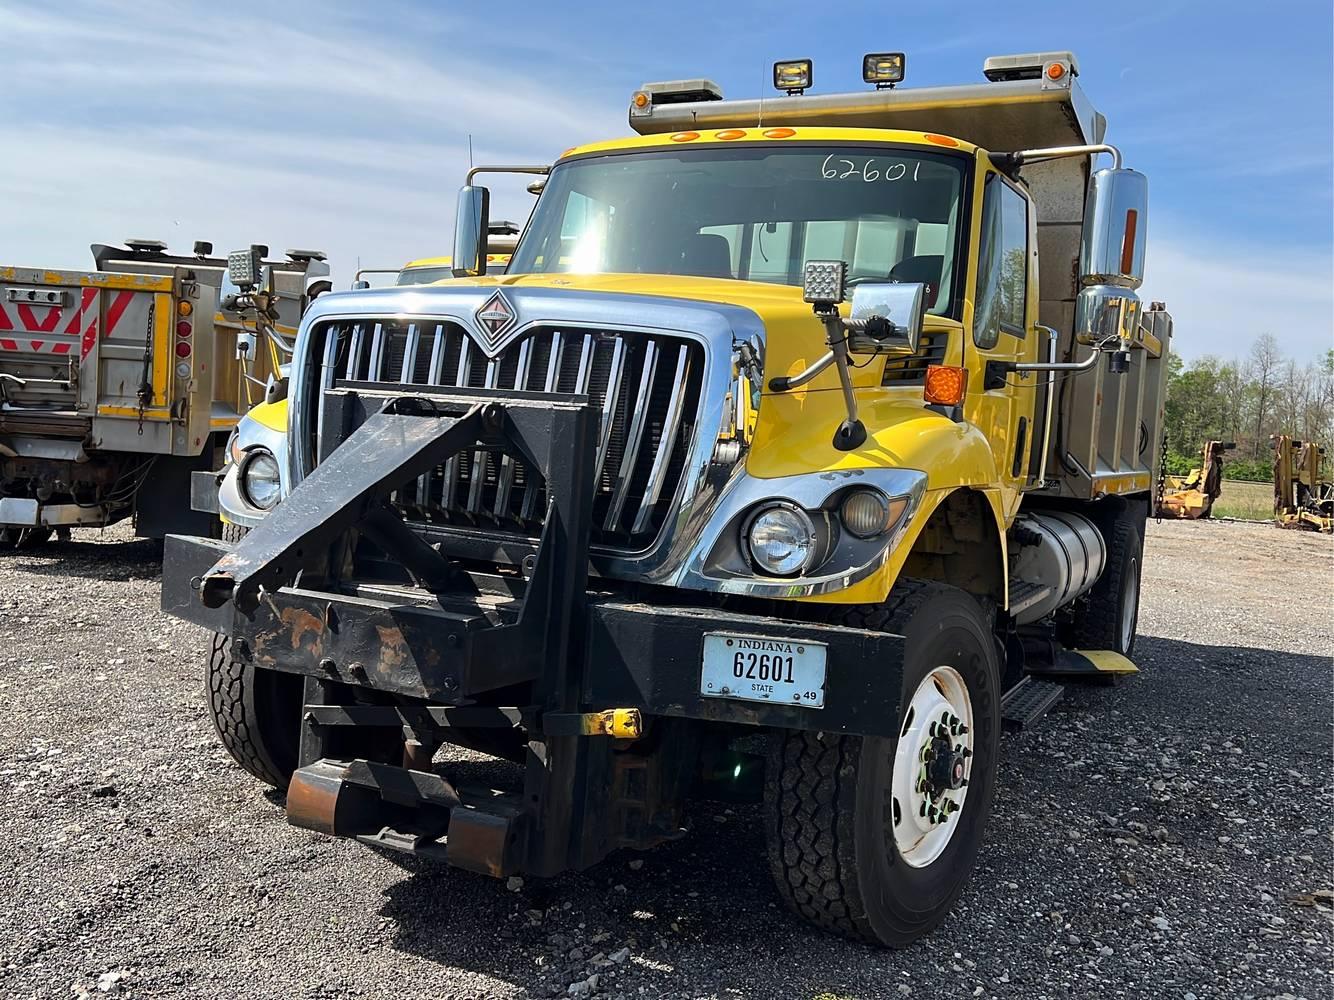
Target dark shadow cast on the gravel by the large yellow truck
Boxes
[368,636,1334,999]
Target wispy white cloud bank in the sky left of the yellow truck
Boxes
[0,3,624,284]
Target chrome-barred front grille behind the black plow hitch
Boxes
[306,320,704,551]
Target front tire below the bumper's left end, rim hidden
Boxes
[205,635,303,789]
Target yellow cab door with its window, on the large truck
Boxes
[964,171,1046,521]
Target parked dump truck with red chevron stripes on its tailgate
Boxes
[0,240,328,547]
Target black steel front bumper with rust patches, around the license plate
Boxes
[163,536,903,736]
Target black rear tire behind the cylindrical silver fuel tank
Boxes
[1066,513,1145,656]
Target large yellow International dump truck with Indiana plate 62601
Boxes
[163,52,1171,945]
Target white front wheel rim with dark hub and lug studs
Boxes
[891,667,974,868]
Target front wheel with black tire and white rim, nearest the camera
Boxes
[764,580,1001,948]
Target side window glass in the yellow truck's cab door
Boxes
[972,175,1029,348]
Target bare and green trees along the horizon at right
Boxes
[1166,333,1334,481]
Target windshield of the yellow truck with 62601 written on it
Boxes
[510,145,967,315]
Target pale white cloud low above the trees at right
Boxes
[1141,231,1334,360]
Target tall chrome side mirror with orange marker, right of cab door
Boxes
[1079,168,1149,288]
